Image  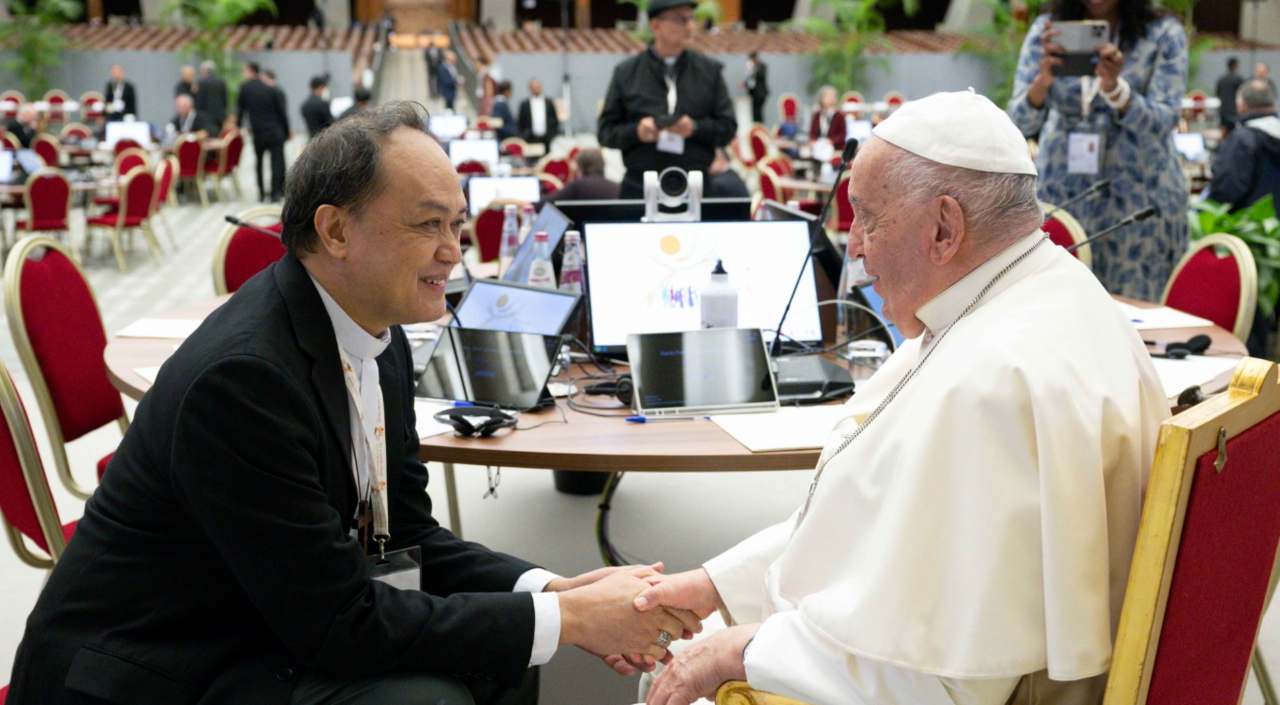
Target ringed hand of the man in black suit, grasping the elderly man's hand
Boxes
[558,572,685,659]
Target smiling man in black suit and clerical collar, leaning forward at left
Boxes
[8,102,699,705]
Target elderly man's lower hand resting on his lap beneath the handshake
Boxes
[645,624,760,705]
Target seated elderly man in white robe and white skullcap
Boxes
[611,92,1169,705]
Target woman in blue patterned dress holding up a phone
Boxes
[1009,0,1187,301]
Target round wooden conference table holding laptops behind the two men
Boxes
[104,297,1247,536]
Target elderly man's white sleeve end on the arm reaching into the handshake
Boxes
[703,514,795,624]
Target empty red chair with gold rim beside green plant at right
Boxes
[1160,233,1258,340]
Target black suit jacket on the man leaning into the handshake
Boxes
[8,255,534,705]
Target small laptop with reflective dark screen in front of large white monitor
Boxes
[627,328,778,417]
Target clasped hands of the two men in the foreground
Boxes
[545,563,723,676]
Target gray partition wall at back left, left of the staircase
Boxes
[0,50,352,133]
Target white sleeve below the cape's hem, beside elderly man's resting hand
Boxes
[745,612,1019,705]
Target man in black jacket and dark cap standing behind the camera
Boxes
[599,0,737,198]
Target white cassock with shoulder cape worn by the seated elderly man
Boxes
[705,232,1169,705]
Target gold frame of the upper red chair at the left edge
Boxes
[4,235,129,499]
